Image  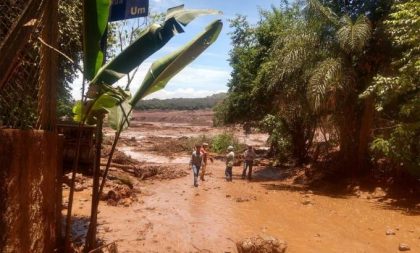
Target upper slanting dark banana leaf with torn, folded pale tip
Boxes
[91,6,219,85]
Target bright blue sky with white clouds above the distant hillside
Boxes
[72,0,280,99]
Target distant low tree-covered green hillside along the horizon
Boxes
[136,93,226,110]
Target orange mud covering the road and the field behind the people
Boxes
[64,111,420,253]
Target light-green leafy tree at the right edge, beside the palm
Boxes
[362,1,420,176]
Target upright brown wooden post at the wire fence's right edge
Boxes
[37,0,58,132]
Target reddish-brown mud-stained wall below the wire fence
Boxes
[0,129,61,253]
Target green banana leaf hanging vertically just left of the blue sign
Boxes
[83,0,110,80]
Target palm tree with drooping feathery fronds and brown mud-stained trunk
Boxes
[307,0,373,173]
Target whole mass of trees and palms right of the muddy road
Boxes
[216,0,420,178]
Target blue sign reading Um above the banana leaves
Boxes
[109,0,149,22]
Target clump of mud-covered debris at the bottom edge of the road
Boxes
[236,235,287,253]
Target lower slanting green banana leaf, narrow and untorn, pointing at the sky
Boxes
[130,20,223,106]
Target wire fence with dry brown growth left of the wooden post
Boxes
[0,0,48,129]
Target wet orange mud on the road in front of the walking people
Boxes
[91,159,420,253]
